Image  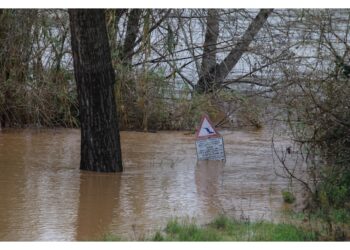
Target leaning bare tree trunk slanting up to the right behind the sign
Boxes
[195,9,273,93]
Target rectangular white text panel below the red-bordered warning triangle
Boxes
[196,137,225,160]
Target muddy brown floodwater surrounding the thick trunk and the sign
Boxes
[0,129,298,241]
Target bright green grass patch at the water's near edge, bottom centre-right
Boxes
[151,216,317,241]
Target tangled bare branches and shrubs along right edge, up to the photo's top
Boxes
[266,10,350,225]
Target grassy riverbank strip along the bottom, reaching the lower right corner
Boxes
[103,214,350,241]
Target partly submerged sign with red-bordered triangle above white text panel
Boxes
[196,115,225,160]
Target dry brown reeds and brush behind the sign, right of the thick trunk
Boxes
[115,66,268,131]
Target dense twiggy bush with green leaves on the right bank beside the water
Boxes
[280,68,350,236]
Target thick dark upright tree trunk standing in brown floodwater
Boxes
[69,9,123,172]
